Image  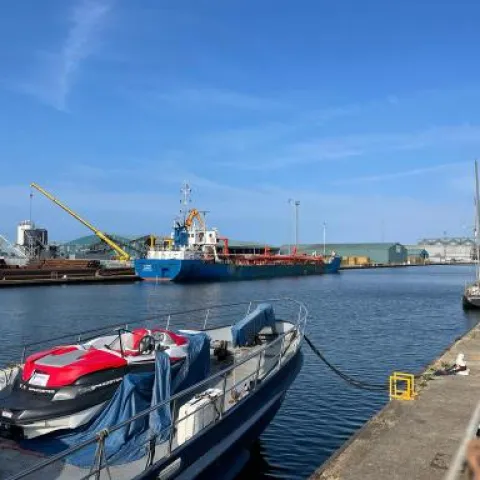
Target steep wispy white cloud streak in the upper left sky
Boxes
[21,0,113,111]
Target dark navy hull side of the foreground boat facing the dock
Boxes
[137,349,303,480]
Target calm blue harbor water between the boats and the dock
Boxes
[0,266,480,479]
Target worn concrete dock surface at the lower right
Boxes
[311,325,480,480]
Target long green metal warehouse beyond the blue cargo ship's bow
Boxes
[282,243,408,265]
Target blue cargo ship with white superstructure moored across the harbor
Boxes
[135,184,341,283]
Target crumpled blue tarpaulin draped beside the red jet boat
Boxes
[22,333,210,467]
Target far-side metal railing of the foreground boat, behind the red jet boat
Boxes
[7,298,305,368]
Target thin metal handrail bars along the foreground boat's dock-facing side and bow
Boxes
[4,298,308,480]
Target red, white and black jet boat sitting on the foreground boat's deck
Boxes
[0,328,188,438]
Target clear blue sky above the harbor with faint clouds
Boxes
[0,0,480,243]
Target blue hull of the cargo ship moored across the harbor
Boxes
[135,257,341,283]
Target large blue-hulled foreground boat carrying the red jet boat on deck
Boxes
[0,299,308,480]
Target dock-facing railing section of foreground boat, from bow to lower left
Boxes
[8,301,308,480]
